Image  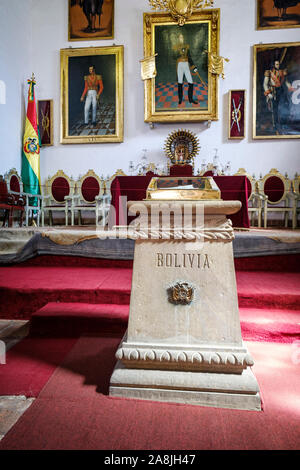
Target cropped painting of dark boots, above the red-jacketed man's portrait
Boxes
[68,0,115,41]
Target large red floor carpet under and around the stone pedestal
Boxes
[0,337,300,450]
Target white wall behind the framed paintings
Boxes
[0,0,300,180]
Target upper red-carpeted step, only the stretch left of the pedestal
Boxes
[0,266,132,319]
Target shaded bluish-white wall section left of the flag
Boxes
[0,0,32,174]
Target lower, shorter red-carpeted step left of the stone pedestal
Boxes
[30,302,129,337]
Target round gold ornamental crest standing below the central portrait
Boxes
[164,129,200,165]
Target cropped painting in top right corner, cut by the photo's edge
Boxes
[256,0,300,29]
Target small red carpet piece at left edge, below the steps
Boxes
[0,338,77,397]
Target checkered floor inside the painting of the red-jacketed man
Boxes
[69,103,116,136]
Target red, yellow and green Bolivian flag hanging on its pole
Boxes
[21,76,41,205]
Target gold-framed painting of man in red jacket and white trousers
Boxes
[60,46,124,144]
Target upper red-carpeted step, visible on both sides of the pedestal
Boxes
[0,266,300,319]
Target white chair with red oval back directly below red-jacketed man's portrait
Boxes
[70,170,109,226]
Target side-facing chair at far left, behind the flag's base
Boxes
[5,168,42,227]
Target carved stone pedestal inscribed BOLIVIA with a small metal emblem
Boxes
[109,200,261,410]
